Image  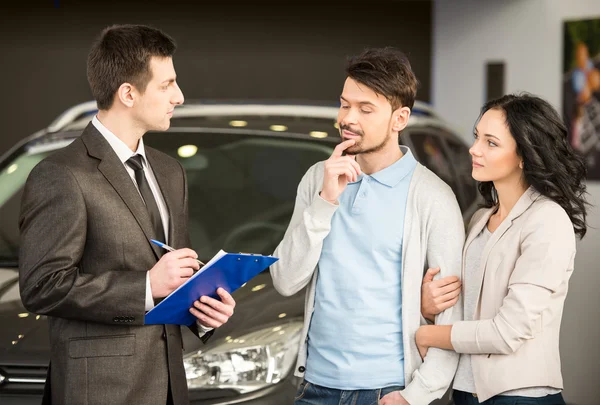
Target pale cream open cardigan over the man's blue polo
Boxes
[271,162,465,405]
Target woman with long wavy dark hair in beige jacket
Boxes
[416,94,587,405]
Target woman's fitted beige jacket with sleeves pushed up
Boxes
[452,187,575,402]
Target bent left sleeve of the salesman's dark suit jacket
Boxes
[19,160,146,325]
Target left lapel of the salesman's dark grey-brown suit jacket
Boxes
[81,123,161,259]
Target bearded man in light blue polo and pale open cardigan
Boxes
[271,48,464,405]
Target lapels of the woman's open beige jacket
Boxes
[472,186,540,313]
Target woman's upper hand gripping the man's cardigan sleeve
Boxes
[421,267,461,322]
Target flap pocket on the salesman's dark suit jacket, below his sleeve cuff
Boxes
[69,335,135,359]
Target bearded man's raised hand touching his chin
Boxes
[321,139,361,203]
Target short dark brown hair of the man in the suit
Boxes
[87,25,177,110]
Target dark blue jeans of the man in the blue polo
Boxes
[294,380,404,405]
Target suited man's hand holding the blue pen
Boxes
[150,249,200,298]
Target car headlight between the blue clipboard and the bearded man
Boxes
[183,322,303,394]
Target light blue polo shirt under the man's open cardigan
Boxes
[305,146,417,390]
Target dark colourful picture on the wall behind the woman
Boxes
[562,17,600,180]
